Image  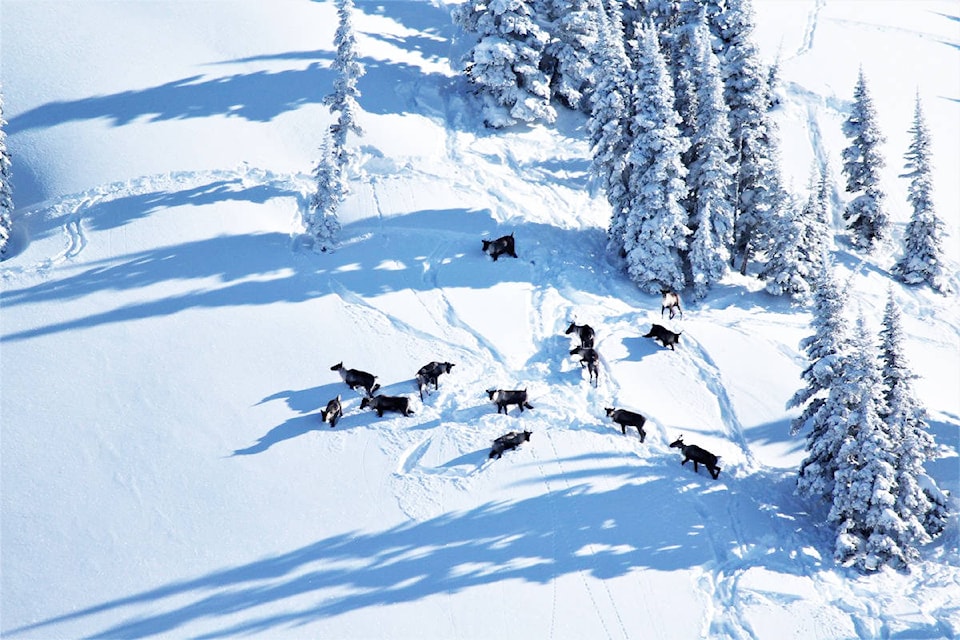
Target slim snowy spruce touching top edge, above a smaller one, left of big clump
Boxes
[323,0,365,152]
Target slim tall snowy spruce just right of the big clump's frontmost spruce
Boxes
[687,20,736,299]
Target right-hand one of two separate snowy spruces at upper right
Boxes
[893,95,947,291]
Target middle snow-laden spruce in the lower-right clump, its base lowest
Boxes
[828,316,917,571]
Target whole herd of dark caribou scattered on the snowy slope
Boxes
[320,238,720,479]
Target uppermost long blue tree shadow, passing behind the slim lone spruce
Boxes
[7,2,454,136]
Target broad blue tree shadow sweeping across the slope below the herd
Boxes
[1,460,829,638]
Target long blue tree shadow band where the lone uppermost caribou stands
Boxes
[0,205,604,342]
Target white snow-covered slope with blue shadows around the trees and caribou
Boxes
[0,0,960,638]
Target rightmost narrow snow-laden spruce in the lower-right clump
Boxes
[880,289,949,536]
